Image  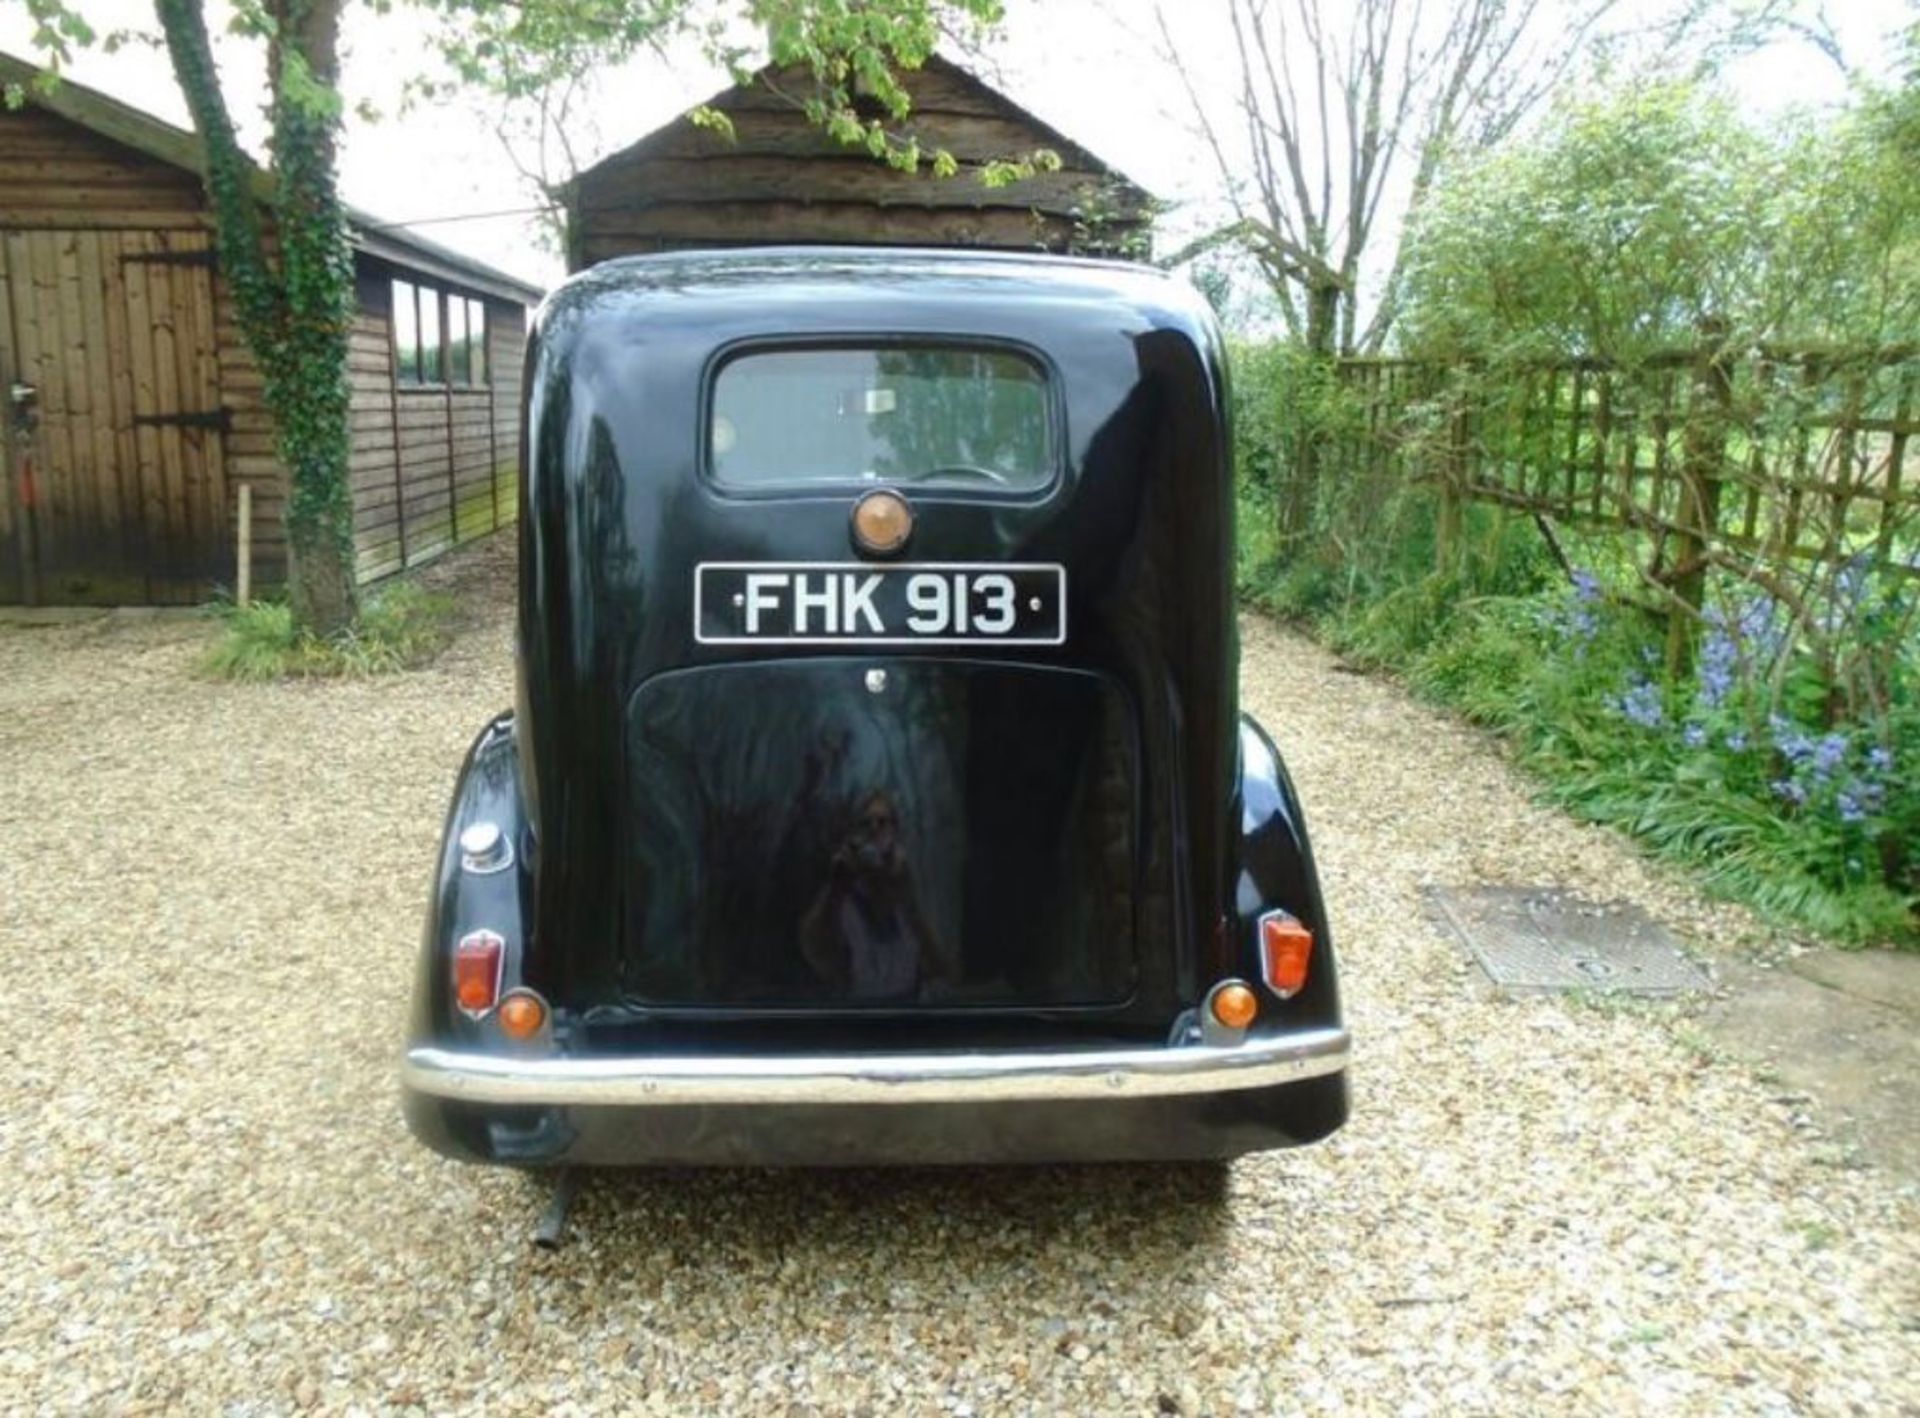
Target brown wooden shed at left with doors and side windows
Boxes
[0,56,540,604]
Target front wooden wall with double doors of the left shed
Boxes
[0,107,230,603]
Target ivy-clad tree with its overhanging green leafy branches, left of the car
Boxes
[27,0,1000,635]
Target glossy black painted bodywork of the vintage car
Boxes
[397,249,1346,1161]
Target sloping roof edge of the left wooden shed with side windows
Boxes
[0,50,541,303]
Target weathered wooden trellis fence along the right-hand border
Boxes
[1313,342,1920,668]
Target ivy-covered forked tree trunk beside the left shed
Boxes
[154,0,355,635]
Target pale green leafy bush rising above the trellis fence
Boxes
[1402,81,1920,361]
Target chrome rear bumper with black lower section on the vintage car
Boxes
[401,1028,1348,1167]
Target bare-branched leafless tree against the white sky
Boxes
[1154,0,1834,355]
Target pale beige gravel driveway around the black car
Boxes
[0,549,1920,1414]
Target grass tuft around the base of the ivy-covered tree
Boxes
[202,581,453,683]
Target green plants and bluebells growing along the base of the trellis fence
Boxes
[1235,333,1920,955]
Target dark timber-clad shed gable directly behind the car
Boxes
[566,56,1152,271]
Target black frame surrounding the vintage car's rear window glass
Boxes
[695,330,1069,503]
